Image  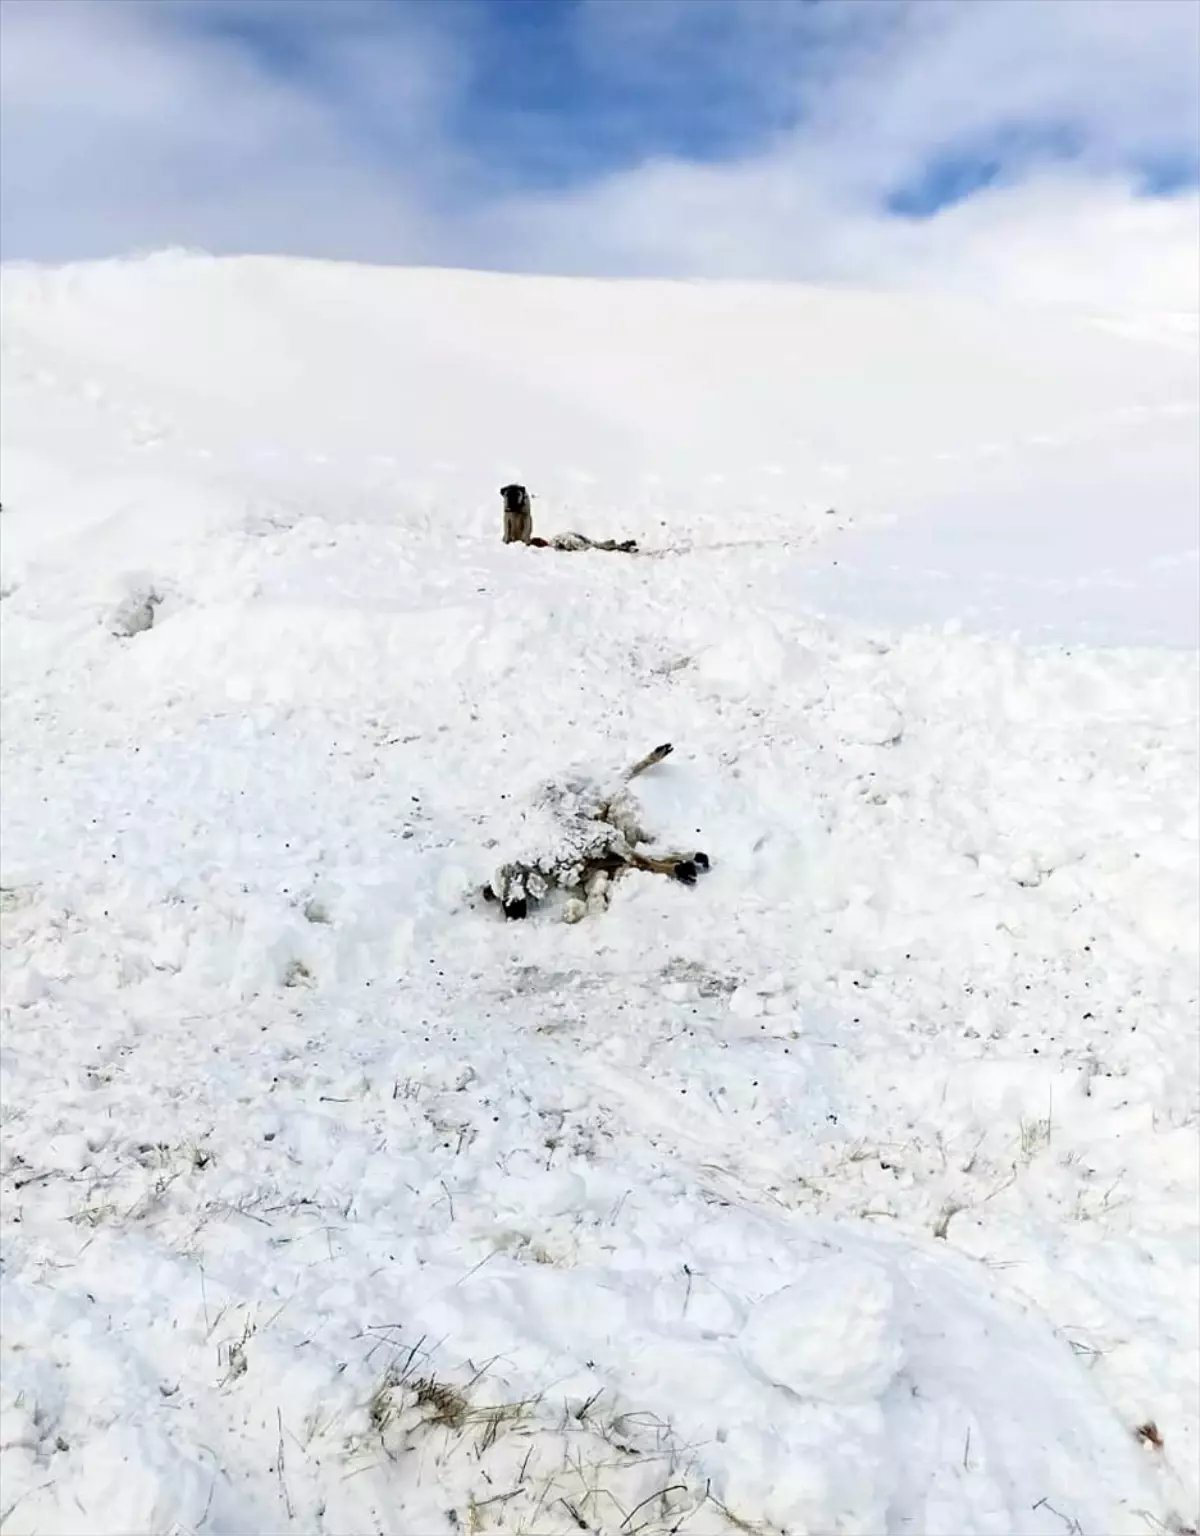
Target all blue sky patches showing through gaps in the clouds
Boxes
[161,0,1200,215]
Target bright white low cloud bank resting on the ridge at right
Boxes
[479,161,1200,310]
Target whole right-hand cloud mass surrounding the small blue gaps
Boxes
[485,0,1200,309]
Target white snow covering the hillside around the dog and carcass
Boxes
[0,252,1200,1536]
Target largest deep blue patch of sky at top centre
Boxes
[192,0,808,187]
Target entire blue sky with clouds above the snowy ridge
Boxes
[0,0,1200,302]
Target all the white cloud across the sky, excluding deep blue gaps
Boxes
[0,0,1200,307]
